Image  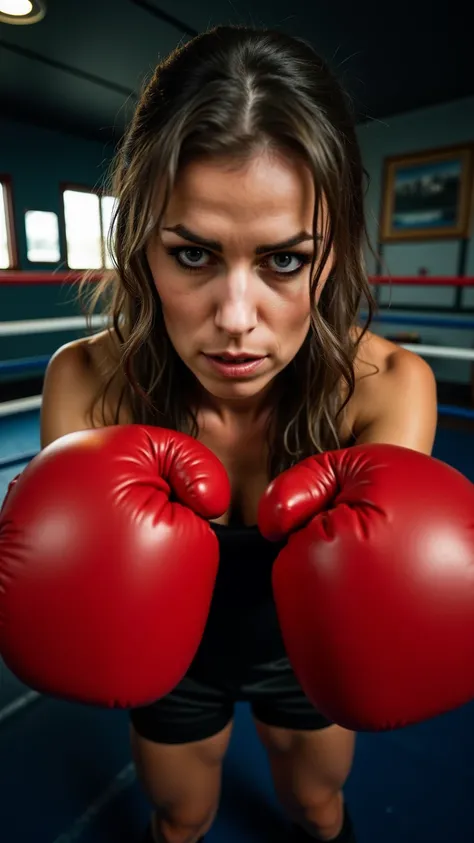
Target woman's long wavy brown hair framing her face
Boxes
[81,26,375,476]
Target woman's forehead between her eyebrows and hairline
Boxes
[165,151,315,230]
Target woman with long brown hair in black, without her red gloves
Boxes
[42,27,436,843]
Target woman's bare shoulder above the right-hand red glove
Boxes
[351,332,437,453]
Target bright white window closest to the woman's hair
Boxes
[63,188,115,269]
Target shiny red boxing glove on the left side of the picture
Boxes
[0,425,230,707]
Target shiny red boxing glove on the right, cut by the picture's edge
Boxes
[259,444,474,731]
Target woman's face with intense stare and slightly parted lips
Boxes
[147,152,331,408]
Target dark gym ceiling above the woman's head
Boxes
[0,0,474,143]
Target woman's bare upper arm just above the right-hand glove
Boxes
[354,349,437,454]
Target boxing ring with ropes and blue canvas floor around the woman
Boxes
[0,272,474,843]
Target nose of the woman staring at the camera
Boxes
[215,267,258,336]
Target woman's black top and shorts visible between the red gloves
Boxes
[131,525,332,744]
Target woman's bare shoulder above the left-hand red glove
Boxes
[41,331,129,446]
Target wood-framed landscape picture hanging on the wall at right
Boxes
[380,144,474,242]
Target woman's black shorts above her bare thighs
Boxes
[131,656,332,744]
